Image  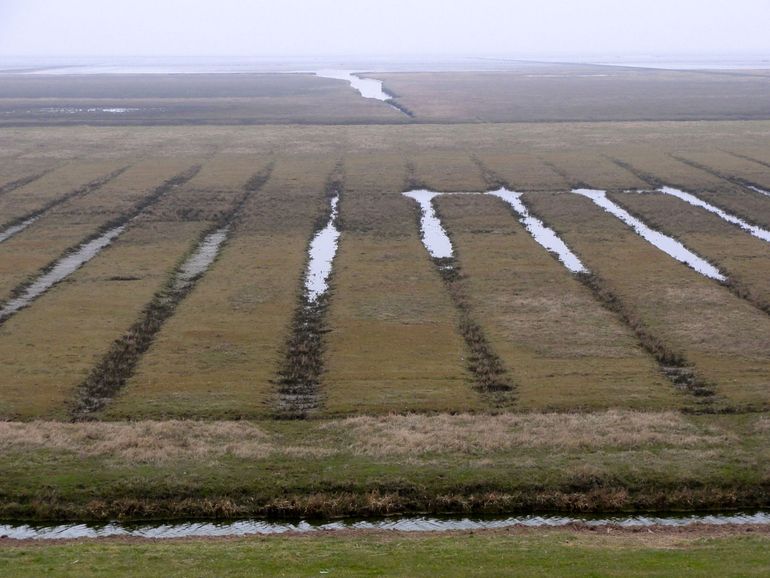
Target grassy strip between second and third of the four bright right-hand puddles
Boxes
[526,193,770,411]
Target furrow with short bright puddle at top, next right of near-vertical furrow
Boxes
[403,189,514,407]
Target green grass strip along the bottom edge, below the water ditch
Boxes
[0,529,770,578]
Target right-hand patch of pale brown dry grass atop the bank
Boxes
[323,410,734,457]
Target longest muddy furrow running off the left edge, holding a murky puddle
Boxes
[0,165,201,325]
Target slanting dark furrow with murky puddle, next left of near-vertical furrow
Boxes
[71,166,272,421]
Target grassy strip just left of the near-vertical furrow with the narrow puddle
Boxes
[100,156,326,420]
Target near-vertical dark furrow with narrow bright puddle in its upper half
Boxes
[274,164,345,419]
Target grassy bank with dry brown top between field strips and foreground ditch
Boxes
[0,411,770,520]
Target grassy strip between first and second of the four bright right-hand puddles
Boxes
[436,194,675,411]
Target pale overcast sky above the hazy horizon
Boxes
[0,0,770,58]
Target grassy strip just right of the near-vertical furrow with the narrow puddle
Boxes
[322,154,474,416]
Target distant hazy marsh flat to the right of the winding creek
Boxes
[372,64,770,122]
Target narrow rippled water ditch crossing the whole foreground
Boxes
[0,512,770,540]
